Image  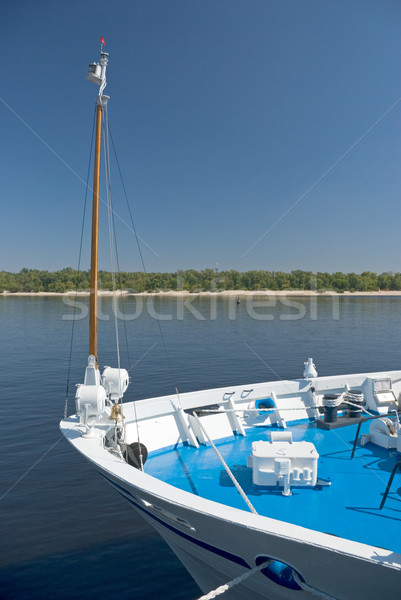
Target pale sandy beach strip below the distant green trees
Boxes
[0,290,401,299]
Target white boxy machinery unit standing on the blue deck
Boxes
[247,431,319,496]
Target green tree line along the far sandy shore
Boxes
[0,267,401,293]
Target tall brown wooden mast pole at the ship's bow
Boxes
[89,102,102,366]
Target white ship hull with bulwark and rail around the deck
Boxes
[60,371,401,600]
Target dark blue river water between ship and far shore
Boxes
[0,297,401,600]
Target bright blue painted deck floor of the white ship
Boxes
[145,423,401,553]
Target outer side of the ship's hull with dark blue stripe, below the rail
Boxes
[97,473,401,600]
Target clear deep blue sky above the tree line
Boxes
[0,0,401,272]
